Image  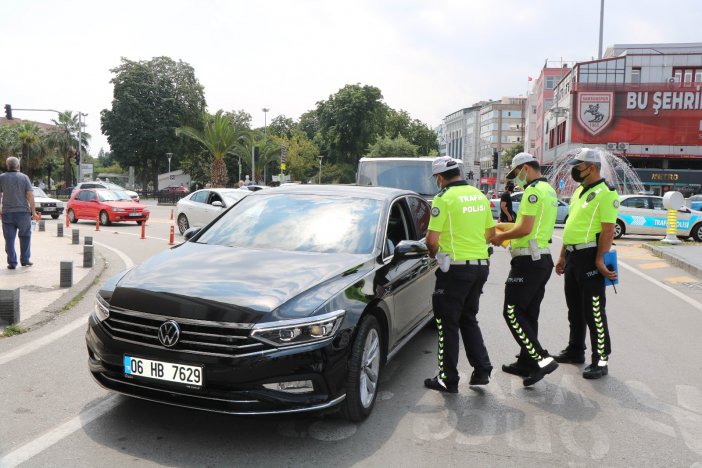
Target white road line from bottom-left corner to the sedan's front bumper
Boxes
[0,394,119,468]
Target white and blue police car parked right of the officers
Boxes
[614,195,702,242]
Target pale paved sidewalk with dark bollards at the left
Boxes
[0,218,104,331]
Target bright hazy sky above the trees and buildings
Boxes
[0,0,702,156]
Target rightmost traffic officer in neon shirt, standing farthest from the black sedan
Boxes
[556,148,619,379]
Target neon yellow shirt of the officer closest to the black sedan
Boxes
[429,181,495,260]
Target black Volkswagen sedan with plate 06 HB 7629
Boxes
[86,185,436,421]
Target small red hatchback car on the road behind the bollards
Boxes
[66,189,149,226]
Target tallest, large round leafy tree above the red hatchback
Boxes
[101,57,208,187]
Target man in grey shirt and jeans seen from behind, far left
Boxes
[0,156,41,270]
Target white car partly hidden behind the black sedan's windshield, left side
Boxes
[176,189,253,234]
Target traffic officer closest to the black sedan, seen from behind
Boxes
[424,156,495,393]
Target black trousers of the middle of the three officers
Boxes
[502,254,553,365]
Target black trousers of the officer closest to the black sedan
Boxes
[432,265,492,383]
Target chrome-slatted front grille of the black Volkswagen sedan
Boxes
[102,307,272,357]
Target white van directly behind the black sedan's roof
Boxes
[356,157,465,199]
